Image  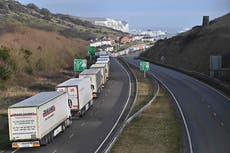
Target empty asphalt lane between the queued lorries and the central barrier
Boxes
[9,58,133,153]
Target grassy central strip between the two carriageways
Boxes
[111,65,180,153]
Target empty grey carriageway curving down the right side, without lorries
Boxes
[125,56,230,153]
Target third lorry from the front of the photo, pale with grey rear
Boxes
[79,69,103,98]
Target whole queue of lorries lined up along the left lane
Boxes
[8,52,110,148]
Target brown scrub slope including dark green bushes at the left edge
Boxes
[0,26,88,88]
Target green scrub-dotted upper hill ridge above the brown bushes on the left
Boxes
[0,0,123,40]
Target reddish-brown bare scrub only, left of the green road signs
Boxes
[0,26,88,72]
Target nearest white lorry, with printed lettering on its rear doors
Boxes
[8,91,71,148]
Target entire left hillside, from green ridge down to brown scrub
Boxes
[0,0,123,89]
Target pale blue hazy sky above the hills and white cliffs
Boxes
[19,0,230,30]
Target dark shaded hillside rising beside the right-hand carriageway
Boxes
[140,14,230,74]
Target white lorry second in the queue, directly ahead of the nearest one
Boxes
[56,78,93,116]
